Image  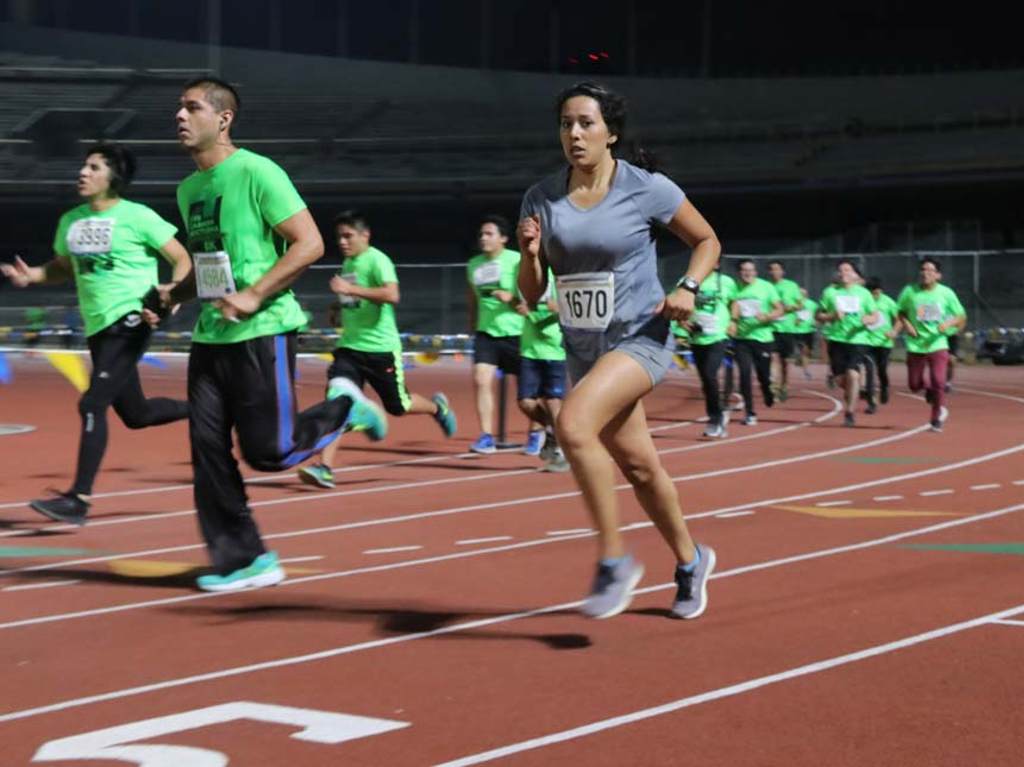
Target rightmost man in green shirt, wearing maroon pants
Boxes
[896,258,967,431]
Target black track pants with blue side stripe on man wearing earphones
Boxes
[188,333,351,574]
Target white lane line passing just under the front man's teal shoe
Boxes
[0,443,1024,630]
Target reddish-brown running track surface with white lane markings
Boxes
[0,360,1024,765]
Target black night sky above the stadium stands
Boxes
[8,0,1024,77]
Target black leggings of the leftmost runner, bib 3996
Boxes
[71,311,188,496]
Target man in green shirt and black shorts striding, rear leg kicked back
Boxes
[299,210,456,487]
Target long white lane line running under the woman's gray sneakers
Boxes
[0,504,1024,723]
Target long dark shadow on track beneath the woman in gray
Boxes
[168,603,593,650]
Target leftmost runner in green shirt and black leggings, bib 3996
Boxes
[0,143,191,525]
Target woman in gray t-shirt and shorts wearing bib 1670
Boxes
[518,83,721,617]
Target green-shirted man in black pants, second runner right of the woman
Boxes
[730,258,782,426]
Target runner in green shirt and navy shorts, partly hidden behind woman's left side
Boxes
[516,268,569,472]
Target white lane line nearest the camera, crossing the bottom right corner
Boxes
[436,605,1024,767]
